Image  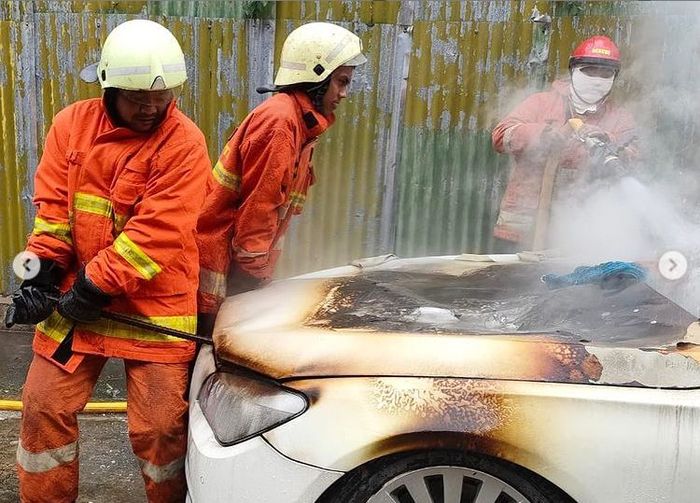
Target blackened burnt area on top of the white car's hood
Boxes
[305,263,695,347]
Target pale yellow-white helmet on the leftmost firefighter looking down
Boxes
[80,19,187,91]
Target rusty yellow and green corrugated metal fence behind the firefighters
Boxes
[0,0,688,292]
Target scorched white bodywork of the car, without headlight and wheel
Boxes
[187,255,700,503]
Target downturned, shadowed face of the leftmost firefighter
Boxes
[115,89,175,133]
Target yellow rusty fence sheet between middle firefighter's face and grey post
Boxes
[276,19,402,276]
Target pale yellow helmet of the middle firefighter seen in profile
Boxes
[275,23,367,87]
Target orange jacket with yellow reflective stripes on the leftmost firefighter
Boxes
[27,99,211,372]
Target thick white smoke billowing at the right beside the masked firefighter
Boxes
[550,2,700,316]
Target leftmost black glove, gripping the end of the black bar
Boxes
[5,259,63,328]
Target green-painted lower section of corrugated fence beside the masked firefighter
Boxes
[396,127,507,256]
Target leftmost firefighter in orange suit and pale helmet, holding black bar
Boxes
[5,20,211,503]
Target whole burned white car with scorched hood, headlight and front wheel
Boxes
[187,255,700,503]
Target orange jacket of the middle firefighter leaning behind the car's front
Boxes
[197,91,334,313]
